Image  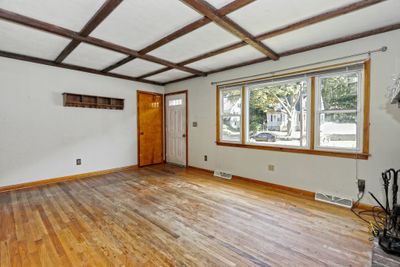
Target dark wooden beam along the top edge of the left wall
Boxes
[0,50,163,85]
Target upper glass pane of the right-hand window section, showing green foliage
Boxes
[320,73,359,110]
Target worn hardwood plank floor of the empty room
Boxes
[0,165,372,267]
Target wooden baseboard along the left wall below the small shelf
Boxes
[0,165,138,193]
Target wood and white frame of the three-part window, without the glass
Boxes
[216,59,371,160]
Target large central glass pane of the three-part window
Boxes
[248,80,308,146]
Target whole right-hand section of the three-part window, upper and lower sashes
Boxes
[316,71,362,151]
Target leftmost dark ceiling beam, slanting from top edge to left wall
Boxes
[55,0,123,63]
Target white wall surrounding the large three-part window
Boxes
[166,31,400,203]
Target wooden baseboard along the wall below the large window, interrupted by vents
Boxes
[188,166,373,210]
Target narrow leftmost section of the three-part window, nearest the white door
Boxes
[220,88,242,142]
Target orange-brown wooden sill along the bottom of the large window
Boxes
[216,141,369,160]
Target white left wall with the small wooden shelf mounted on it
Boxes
[0,58,164,187]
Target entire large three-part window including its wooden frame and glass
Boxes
[217,61,370,159]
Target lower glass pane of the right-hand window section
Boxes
[319,112,357,149]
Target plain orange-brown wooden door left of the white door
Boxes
[137,91,163,167]
